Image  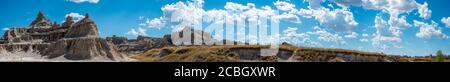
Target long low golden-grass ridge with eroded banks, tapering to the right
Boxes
[133,45,400,62]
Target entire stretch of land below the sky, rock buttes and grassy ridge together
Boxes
[0,12,432,62]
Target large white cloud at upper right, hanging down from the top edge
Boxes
[333,0,431,44]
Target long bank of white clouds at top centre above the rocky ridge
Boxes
[146,0,308,31]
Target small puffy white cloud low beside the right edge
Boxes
[414,20,449,39]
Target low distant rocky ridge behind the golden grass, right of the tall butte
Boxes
[106,27,219,52]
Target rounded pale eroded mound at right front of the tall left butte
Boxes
[42,37,123,60]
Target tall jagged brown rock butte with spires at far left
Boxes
[0,12,124,61]
